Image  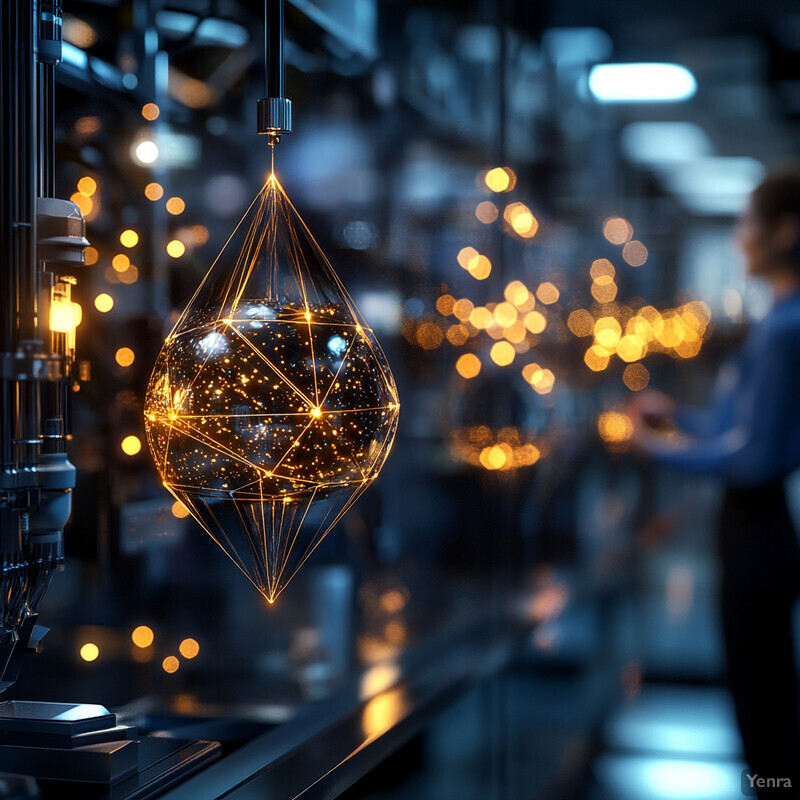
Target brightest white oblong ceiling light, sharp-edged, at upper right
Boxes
[589,64,697,103]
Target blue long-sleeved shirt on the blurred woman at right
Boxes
[649,292,800,487]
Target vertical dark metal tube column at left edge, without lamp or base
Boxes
[0,0,83,691]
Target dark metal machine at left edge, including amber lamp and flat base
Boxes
[0,0,219,798]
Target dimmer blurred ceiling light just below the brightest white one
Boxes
[620,122,714,165]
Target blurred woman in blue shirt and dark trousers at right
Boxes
[631,171,800,798]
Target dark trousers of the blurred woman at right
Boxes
[717,483,800,799]
